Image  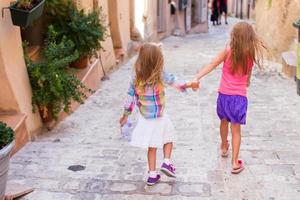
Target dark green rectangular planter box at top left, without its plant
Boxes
[9,0,46,28]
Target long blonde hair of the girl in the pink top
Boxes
[230,22,267,74]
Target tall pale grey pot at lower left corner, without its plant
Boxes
[0,141,15,200]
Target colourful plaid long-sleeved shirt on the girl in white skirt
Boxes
[124,72,186,119]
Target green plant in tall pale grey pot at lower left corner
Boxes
[0,121,14,199]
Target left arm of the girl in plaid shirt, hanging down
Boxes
[120,81,136,126]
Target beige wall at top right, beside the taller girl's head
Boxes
[255,0,300,60]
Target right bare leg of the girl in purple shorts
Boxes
[231,124,241,168]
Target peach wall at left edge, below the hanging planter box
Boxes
[0,0,42,134]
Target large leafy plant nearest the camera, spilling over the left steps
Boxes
[25,26,92,119]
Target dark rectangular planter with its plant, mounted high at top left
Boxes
[9,0,45,27]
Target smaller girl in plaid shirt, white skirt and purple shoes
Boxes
[120,43,199,185]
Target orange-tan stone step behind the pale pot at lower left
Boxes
[0,113,30,156]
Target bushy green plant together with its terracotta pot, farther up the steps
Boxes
[54,6,107,68]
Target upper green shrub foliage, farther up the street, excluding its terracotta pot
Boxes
[47,0,107,57]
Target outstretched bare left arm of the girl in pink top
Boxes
[194,49,227,82]
